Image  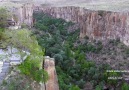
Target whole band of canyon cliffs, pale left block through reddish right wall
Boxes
[1,0,129,46]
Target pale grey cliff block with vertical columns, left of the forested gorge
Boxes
[12,3,33,27]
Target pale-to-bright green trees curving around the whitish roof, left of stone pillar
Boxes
[2,29,48,82]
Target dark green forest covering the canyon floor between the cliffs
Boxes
[34,13,127,90]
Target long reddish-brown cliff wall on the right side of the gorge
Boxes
[39,6,129,45]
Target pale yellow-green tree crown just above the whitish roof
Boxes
[5,29,44,57]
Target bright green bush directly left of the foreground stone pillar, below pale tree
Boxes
[19,57,48,82]
